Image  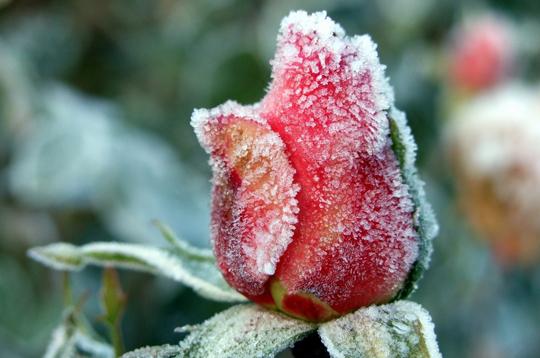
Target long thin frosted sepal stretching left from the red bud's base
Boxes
[28,242,245,302]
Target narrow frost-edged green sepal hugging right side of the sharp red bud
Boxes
[389,107,439,299]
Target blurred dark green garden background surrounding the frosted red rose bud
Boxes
[0,0,540,358]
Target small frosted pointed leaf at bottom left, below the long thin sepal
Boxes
[44,309,114,358]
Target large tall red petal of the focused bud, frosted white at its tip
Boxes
[261,12,418,314]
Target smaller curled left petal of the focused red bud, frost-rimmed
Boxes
[192,102,299,299]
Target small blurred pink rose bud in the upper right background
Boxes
[449,16,515,92]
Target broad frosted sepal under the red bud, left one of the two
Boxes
[180,304,316,358]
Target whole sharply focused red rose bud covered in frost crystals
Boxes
[192,12,436,321]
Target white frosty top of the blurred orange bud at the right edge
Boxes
[447,84,540,229]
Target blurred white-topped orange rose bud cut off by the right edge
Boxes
[446,85,540,265]
